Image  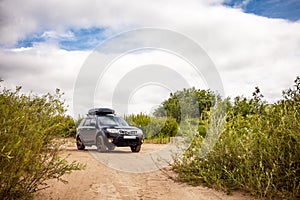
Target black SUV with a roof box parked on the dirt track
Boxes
[76,108,143,152]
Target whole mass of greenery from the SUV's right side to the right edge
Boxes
[123,77,300,199]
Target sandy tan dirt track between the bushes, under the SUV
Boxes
[35,144,250,200]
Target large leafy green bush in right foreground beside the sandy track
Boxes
[173,77,300,199]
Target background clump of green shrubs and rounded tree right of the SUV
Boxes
[126,88,214,143]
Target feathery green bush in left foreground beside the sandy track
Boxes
[0,83,83,199]
